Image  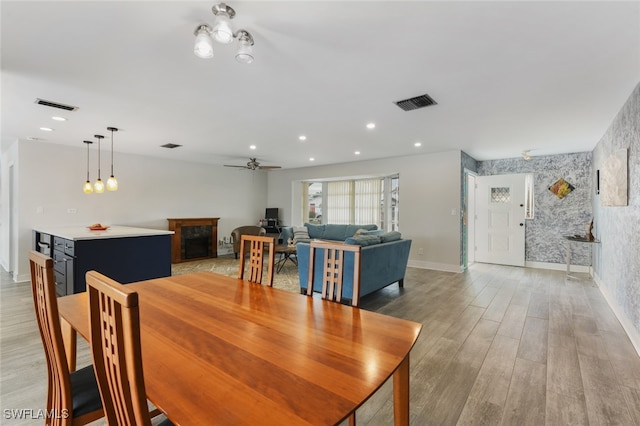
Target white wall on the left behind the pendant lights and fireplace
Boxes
[0,141,267,281]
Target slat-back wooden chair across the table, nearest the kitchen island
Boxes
[238,235,275,287]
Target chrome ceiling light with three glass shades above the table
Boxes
[193,3,254,64]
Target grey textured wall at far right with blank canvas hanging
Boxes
[591,84,640,334]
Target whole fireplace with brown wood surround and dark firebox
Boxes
[167,217,218,263]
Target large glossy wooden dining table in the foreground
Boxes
[58,272,422,425]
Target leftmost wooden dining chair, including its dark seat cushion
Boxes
[29,251,104,425]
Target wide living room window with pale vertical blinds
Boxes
[302,175,399,231]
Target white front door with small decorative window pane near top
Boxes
[475,175,525,266]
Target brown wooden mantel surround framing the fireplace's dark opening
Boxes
[167,217,220,263]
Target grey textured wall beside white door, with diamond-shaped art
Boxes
[478,151,597,265]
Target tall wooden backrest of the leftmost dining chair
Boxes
[29,251,104,425]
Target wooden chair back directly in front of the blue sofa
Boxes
[307,241,362,306]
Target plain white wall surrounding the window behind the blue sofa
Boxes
[268,151,461,272]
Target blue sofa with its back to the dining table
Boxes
[282,224,411,302]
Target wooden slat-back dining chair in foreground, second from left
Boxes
[86,271,172,426]
